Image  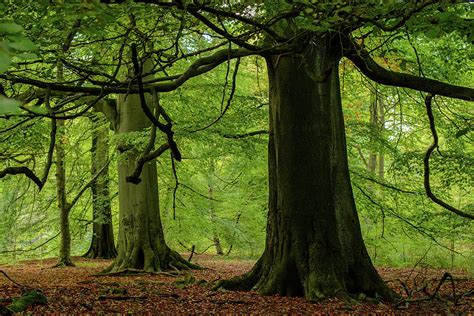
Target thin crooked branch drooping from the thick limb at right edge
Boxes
[423,94,474,219]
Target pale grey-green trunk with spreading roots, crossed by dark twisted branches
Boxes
[105,90,192,272]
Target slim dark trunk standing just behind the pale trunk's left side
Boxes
[83,114,117,259]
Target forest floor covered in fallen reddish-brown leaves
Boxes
[0,255,474,315]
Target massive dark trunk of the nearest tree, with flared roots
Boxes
[218,37,395,300]
